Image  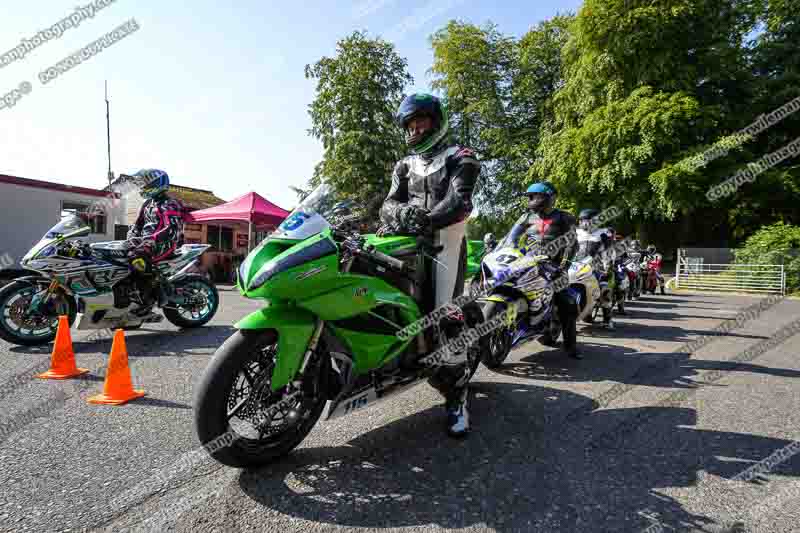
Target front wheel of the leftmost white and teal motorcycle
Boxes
[0,280,78,346]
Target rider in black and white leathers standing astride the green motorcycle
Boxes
[379,94,481,437]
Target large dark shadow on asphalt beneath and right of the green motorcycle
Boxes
[234,382,800,532]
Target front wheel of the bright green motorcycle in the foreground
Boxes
[194,330,330,468]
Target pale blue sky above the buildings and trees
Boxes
[0,0,580,208]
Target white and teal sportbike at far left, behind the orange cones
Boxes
[0,214,219,346]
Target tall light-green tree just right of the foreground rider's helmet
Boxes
[430,15,571,218]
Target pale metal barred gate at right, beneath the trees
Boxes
[669,248,786,295]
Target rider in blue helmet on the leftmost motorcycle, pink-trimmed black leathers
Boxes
[127,169,185,311]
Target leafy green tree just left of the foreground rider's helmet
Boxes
[305,31,413,216]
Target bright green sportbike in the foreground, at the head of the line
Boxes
[194,184,484,468]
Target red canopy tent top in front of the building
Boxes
[186,192,289,249]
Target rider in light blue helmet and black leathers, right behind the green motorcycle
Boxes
[510,181,583,359]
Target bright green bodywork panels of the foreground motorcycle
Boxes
[234,225,421,390]
